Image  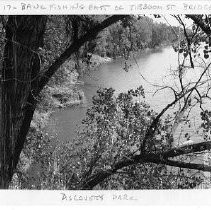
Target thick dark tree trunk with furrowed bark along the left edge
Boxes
[0,16,46,189]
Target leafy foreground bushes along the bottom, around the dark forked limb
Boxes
[10,86,202,189]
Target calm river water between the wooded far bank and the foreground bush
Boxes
[47,46,204,142]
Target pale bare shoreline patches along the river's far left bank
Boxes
[31,43,171,128]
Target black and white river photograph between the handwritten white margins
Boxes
[0,0,211,207]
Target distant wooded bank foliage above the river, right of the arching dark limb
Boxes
[95,16,178,59]
